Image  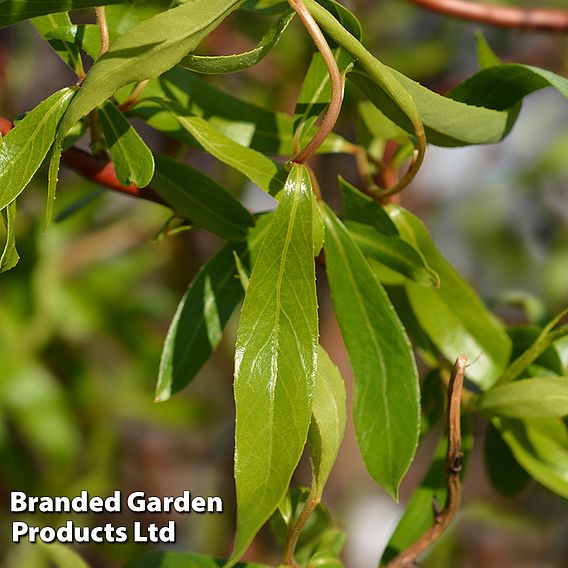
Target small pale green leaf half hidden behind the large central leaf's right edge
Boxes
[308,347,347,502]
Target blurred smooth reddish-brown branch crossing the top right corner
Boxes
[410,0,568,33]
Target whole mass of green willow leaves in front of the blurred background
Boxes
[0,0,568,567]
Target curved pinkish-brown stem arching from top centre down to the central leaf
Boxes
[288,0,344,164]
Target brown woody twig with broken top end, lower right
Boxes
[387,355,467,568]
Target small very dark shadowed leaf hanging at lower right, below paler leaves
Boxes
[483,423,531,497]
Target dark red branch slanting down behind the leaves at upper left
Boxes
[0,117,165,207]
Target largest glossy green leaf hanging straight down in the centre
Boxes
[231,165,318,561]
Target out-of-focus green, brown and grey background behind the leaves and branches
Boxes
[0,0,568,568]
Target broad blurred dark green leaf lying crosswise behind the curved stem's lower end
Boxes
[131,67,351,155]
